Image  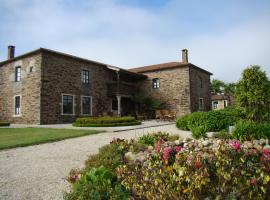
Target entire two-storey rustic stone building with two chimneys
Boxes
[0,46,211,124]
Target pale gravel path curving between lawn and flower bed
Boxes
[0,124,190,200]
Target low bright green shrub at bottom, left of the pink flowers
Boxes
[64,166,129,200]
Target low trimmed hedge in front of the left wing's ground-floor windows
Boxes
[73,117,141,127]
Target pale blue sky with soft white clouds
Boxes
[0,0,270,82]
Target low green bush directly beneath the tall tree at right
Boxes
[233,120,270,141]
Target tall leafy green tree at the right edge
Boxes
[236,65,270,122]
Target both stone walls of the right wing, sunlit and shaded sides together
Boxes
[138,65,211,117]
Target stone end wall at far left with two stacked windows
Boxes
[0,54,41,124]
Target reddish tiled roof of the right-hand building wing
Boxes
[129,62,213,75]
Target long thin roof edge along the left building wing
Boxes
[0,48,146,78]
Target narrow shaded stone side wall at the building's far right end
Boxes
[190,67,211,112]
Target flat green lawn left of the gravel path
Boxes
[0,128,101,149]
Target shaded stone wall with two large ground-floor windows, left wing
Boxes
[41,52,114,124]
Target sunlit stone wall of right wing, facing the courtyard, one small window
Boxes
[140,67,190,116]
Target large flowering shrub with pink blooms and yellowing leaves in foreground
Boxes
[117,140,270,199]
